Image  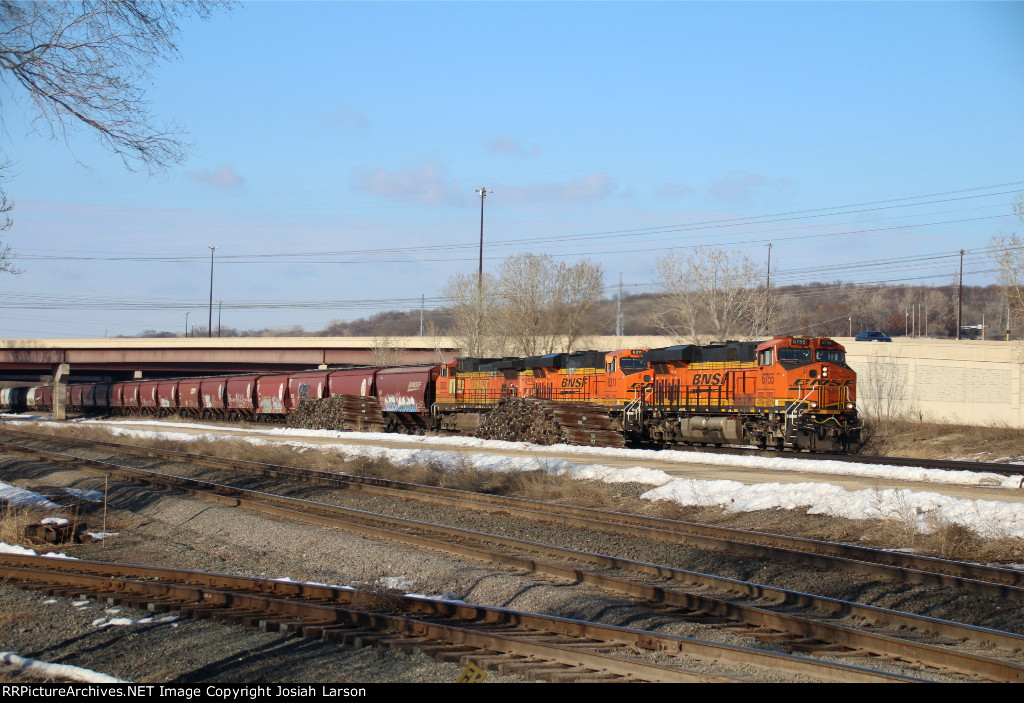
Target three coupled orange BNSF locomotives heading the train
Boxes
[433,337,860,451]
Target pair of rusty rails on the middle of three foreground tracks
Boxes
[4,440,1024,680]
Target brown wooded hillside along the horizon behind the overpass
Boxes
[130,275,1024,345]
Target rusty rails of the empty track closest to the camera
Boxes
[0,556,920,683]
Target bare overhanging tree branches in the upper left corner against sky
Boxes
[0,0,227,271]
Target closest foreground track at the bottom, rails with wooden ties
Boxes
[0,555,790,683]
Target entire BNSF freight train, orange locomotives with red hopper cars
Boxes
[0,337,860,451]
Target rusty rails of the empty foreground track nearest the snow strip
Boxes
[2,428,1024,602]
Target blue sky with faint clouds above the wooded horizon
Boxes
[0,2,1024,338]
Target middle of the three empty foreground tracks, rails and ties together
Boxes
[4,429,1024,680]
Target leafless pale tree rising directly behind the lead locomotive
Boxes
[652,247,767,344]
